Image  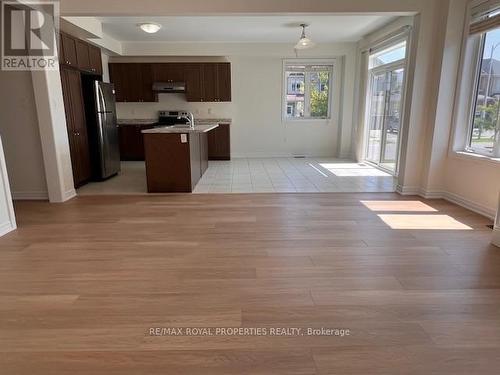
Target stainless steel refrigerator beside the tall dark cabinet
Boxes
[84,79,120,180]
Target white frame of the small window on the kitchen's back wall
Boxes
[281,58,338,123]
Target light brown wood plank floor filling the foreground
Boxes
[0,193,500,375]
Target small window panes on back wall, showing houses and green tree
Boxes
[284,63,333,120]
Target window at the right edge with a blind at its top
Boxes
[465,4,500,157]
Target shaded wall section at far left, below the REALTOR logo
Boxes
[0,71,48,199]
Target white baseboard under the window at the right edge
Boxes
[396,185,496,220]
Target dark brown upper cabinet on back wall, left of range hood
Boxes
[109,63,156,102]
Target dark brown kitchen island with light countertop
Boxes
[142,124,218,193]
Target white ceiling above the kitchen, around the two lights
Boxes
[98,14,396,43]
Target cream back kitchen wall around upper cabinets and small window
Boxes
[110,43,356,157]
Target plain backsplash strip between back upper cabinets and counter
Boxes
[116,94,233,119]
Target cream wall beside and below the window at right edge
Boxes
[422,0,500,218]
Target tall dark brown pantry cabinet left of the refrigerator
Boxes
[61,68,92,187]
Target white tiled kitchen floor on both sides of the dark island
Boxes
[78,158,395,195]
